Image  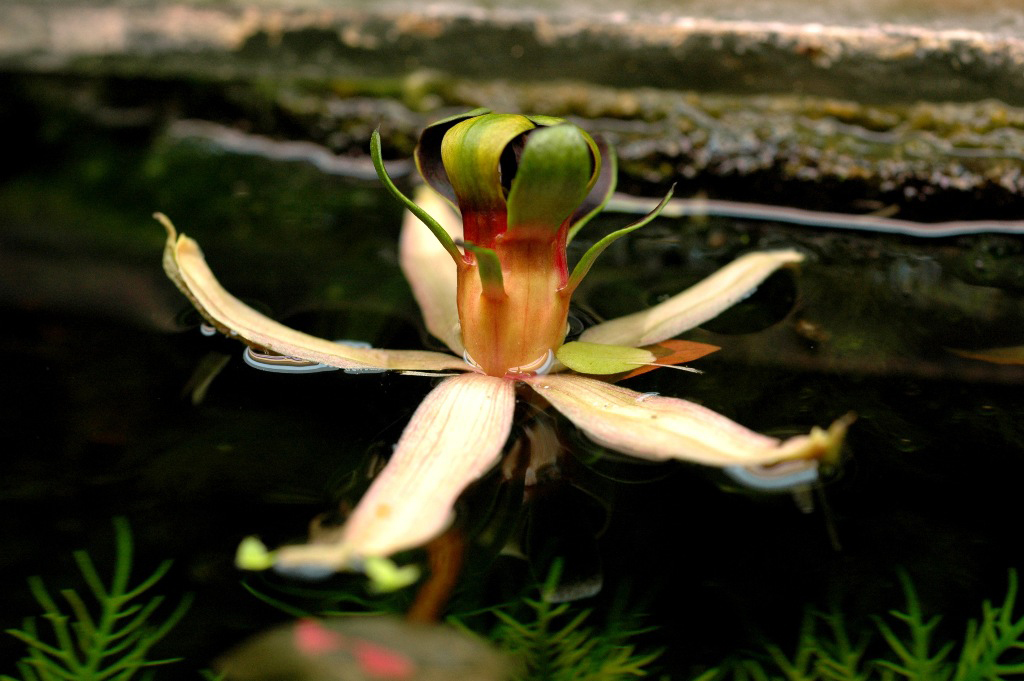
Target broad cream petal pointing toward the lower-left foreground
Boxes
[276,374,515,569]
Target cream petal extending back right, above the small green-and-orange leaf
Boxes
[580,250,804,345]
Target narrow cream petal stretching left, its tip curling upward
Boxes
[157,215,472,371]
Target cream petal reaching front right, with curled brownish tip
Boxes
[526,375,850,466]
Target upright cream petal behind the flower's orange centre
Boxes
[398,186,465,355]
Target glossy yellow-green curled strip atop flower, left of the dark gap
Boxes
[441,114,535,209]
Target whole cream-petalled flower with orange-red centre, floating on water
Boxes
[158,110,847,582]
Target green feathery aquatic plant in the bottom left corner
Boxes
[0,518,191,681]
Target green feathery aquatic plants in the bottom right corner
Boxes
[700,570,1024,681]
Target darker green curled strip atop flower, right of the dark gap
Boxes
[508,124,599,231]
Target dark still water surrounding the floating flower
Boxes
[0,73,1024,678]
